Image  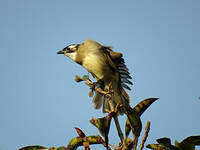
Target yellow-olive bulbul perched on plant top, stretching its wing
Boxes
[57,39,132,114]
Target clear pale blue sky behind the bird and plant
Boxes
[0,0,200,150]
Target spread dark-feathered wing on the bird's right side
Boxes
[104,47,133,90]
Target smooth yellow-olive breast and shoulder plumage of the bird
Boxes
[77,40,117,80]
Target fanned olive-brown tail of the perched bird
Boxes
[93,87,130,115]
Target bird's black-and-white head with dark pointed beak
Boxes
[57,44,79,60]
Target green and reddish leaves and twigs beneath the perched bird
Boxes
[19,75,200,150]
